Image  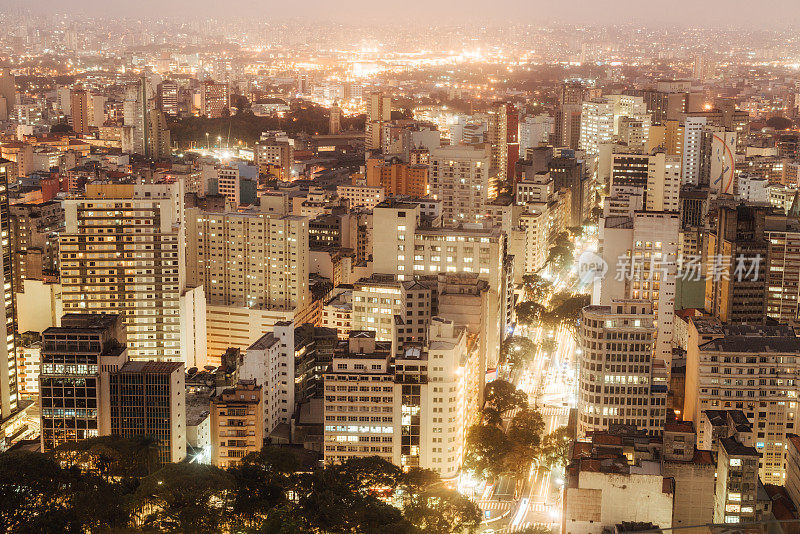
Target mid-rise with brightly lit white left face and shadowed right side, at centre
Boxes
[351,274,436,349]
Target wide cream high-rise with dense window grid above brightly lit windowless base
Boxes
[186,208,311,354]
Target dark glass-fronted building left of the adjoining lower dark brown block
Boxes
[39,313,128,451]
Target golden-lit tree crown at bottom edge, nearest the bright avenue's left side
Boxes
[403,487,482,534]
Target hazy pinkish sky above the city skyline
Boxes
[0,0,800,28]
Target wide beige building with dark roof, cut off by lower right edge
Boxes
[683,318,800,485]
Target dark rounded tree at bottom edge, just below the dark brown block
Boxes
[136,463,235,533]
